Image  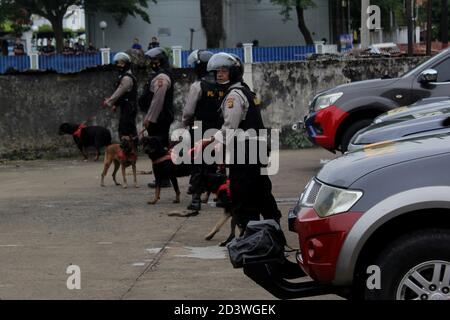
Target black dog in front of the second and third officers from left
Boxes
[141,137,191,204]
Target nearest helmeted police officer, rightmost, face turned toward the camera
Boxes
[201,53,281,229]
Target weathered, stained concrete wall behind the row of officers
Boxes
[0,59,426,159]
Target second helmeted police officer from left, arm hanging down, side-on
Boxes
[139,47,174,187]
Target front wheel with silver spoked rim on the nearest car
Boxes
[364,229,450,300]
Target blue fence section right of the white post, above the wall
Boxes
[253,46,316,62]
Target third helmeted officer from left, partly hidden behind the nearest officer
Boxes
[182,50,228,211]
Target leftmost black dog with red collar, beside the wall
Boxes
[59,123,111,161]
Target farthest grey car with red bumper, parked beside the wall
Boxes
[304,48,450,152]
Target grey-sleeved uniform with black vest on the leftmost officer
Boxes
[106,70,137,137]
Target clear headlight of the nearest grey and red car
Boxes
[314,184,363,218]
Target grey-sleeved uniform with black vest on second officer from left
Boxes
[144,70,174,147]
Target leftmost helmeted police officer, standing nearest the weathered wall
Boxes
[103,52,138,145]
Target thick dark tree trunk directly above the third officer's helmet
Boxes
[200,0,225,48]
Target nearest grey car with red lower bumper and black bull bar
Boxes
[234,130,450,300]
